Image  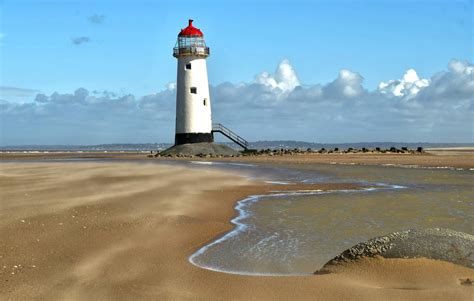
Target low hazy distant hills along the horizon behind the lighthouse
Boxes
[0,140,474,152]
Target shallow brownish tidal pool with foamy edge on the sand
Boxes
[190,164,474,275]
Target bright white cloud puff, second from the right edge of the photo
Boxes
[378,69,429,98]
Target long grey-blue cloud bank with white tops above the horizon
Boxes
[0,60,474,145]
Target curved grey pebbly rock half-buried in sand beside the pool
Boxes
[318,228,474,272]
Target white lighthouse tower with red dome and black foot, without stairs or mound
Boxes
[173,20,214,145]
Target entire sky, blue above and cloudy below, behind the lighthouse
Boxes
[0,0,474,145]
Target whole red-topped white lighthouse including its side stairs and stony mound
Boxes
[160,20,249,156]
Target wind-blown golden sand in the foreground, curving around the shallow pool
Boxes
[0,163,474,300]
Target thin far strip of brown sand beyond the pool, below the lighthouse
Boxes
[0,149,474,170]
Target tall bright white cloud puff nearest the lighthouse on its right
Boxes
[255,59,300,92]
